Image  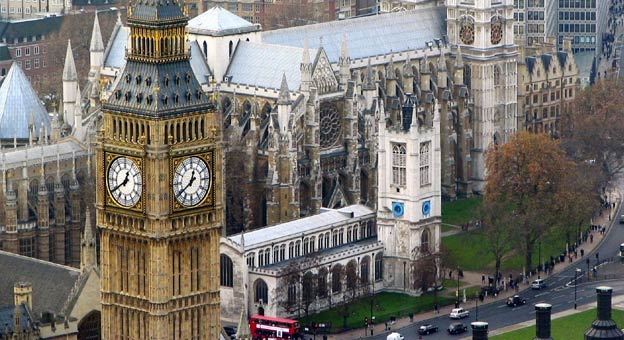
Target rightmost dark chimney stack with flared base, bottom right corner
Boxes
[585,286,624,340]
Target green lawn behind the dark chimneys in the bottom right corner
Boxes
[490,309,624,340]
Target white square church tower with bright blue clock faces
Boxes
[377,51,441,293]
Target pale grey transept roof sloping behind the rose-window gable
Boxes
[225,41,318,91]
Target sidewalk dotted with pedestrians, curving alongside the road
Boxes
[330,189,624,340]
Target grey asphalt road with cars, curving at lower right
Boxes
[370,206,624,340]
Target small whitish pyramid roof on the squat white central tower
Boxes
[187,6,261,37]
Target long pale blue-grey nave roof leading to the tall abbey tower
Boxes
[262,6,446,63]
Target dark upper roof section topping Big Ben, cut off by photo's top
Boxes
[128,0,186,23]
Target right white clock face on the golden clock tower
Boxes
[173,156,210,207]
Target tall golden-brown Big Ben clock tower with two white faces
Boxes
[96,0,223,340]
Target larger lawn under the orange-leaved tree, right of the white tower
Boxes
[442,226,566,275]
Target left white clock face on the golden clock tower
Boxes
[107,157,143,207]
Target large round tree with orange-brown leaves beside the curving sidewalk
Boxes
[484,132,576,270]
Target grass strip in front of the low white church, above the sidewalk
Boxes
[301,292,455,332]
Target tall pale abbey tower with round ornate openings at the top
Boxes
[446,0,518,191]
